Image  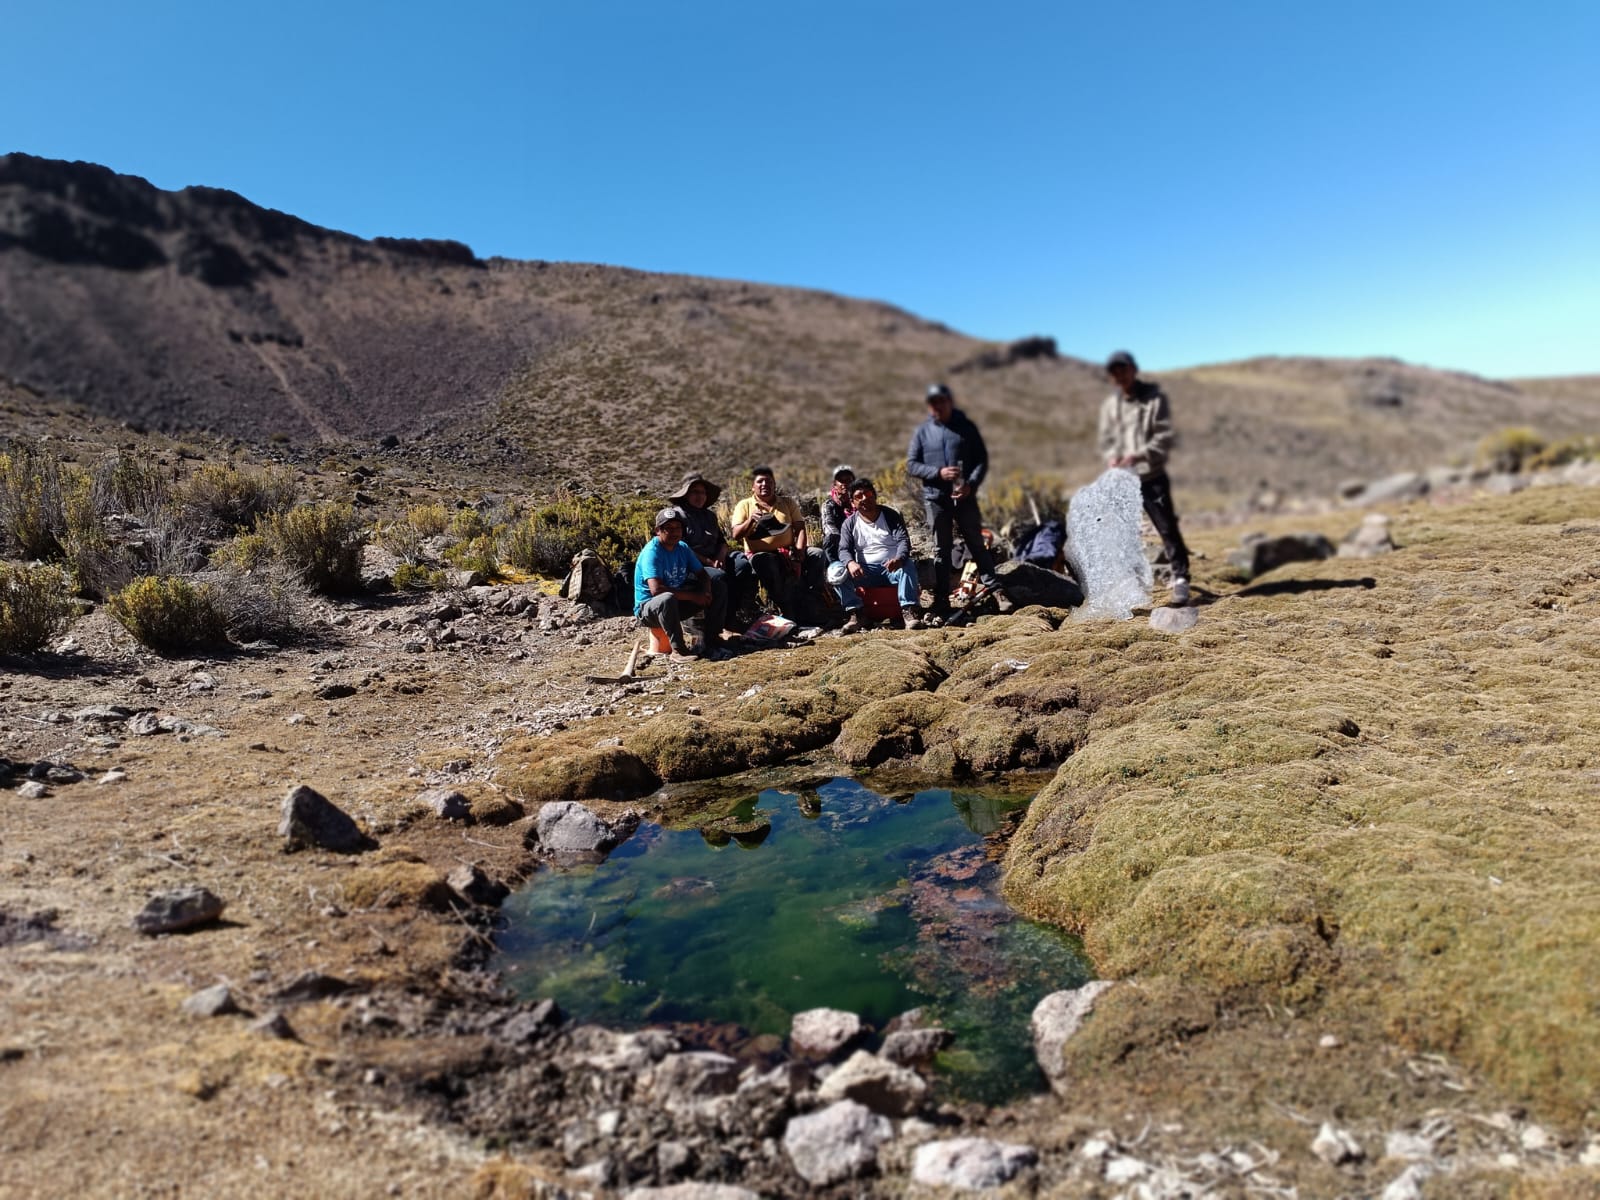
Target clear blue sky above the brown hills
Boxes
[0,0,1600,376]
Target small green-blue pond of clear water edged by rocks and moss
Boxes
[496,779,1090,1102]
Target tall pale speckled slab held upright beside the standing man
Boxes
[1067,467,1154,621]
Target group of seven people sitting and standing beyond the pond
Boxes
[634,350,1189,658]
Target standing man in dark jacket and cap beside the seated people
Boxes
[906,384,1000,621]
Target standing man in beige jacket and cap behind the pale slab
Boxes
[1099,350,1189,605]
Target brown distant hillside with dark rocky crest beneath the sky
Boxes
[0,154,1600,501]
